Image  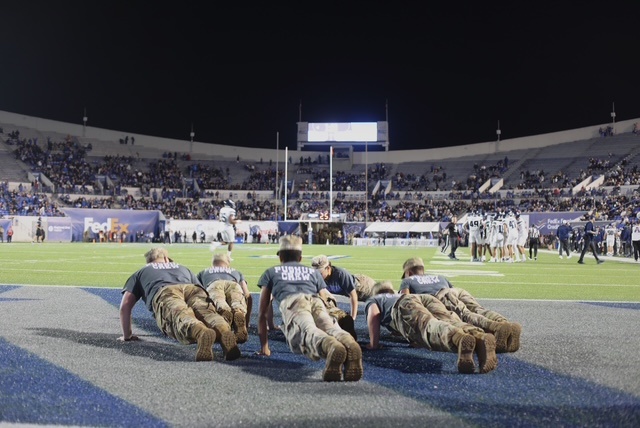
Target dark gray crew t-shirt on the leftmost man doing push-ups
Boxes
[122,262,202,312]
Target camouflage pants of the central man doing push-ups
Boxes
[279,294,351,361]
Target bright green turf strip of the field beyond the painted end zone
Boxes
[0,243,640,302]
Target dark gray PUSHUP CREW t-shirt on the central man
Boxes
[258,262,327,303]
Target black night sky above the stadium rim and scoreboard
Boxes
[0,1,640,150]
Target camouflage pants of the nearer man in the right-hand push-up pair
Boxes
[390,294,484,352]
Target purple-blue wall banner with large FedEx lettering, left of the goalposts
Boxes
[61,208,160,242]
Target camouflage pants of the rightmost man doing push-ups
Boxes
[436,288,507,333]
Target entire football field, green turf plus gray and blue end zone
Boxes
[0,243,640,428]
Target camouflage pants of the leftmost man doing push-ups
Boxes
[152,284,231,345]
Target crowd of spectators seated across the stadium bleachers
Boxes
[0,127,640,226]
